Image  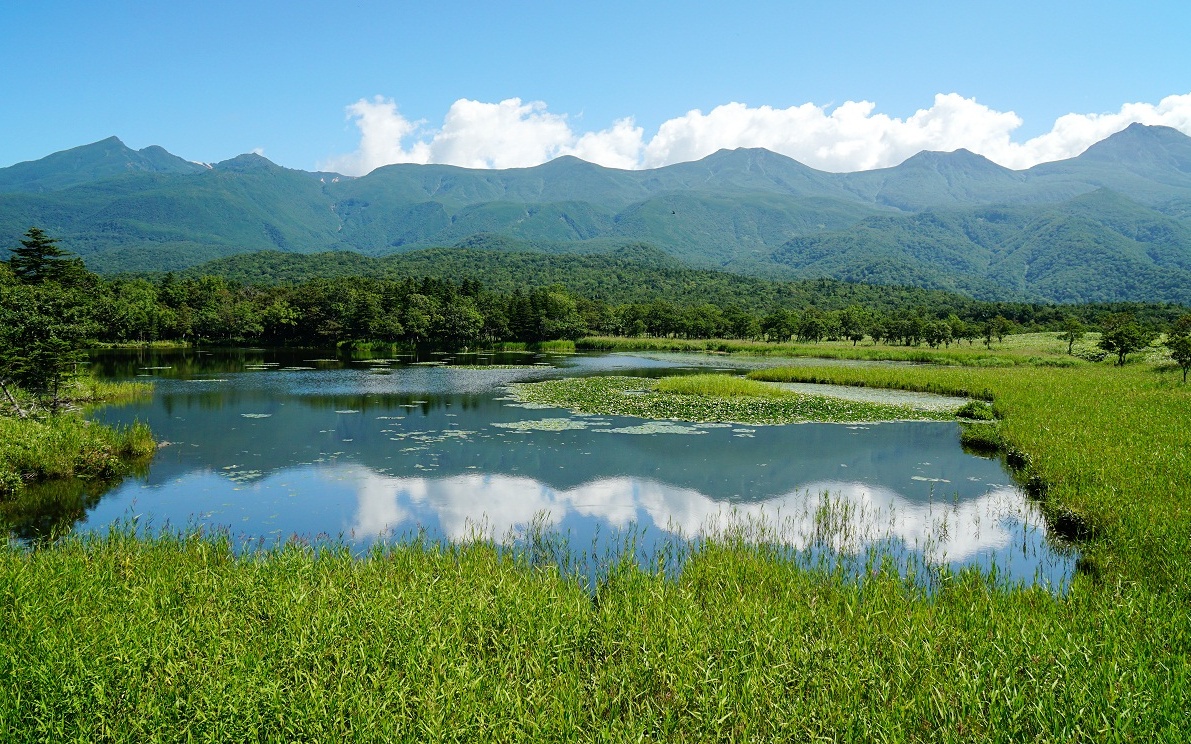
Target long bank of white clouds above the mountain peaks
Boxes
[320,93,1191,175]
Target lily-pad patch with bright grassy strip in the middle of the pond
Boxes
[510,375,955,425]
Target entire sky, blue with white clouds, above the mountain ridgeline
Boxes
[0,0,1191,173]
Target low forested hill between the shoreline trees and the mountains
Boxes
[172,244,1184,329]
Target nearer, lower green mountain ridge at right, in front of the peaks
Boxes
[772,189,1191,304]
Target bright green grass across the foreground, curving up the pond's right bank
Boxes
[0,342,1191,742]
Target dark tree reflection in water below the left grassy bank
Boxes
[0,461,148,544]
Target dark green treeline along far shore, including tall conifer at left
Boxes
[0,231,1185,354]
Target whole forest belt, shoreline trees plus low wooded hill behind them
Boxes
[0,229,1185,361]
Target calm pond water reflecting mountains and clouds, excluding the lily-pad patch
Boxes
[18,350,1073,586]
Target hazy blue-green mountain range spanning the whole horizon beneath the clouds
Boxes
[0,124,1191,305]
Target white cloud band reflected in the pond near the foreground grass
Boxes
[335,467,1043,561]
